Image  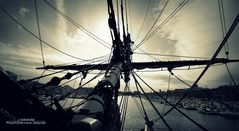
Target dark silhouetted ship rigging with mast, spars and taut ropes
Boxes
[0,0,239,131]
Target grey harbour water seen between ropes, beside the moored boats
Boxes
[60,97,239,131]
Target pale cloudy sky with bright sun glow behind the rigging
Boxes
[0,0,239,90]
